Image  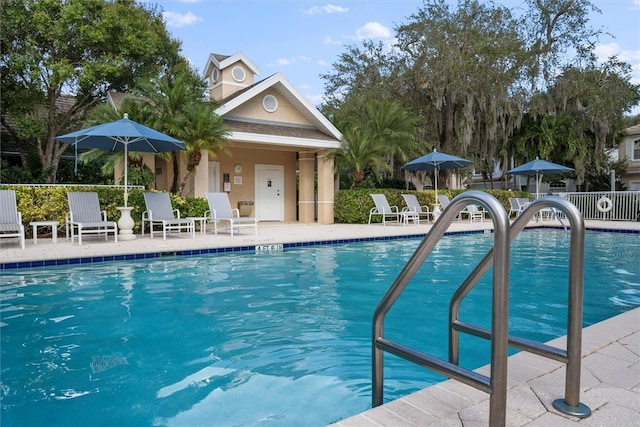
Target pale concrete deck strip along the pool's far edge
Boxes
[0,217,640,270]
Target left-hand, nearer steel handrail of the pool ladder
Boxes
[372,191,510,426]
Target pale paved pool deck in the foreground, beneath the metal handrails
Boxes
[333,308,640,427]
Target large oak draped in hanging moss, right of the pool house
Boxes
[323,0,637,191]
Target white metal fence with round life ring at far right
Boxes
[553,191,640,221]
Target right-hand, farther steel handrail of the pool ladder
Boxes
[449,196,591,418]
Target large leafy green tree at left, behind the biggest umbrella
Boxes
[0,0,184,182]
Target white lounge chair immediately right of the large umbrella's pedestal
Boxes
[142,193,196,240]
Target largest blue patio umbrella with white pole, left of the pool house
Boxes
[55,114,186,207]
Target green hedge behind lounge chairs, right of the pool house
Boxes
[334,188,529,224]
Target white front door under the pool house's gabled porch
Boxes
[255,165,284,221]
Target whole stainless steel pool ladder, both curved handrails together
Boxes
[372,191,591,427]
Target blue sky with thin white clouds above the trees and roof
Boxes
[155,0,640,112]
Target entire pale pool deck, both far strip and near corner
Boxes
[0,221,640,427]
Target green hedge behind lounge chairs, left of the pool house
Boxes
[0,186,209,237]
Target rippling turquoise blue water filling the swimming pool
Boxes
[0,231,640,427]
